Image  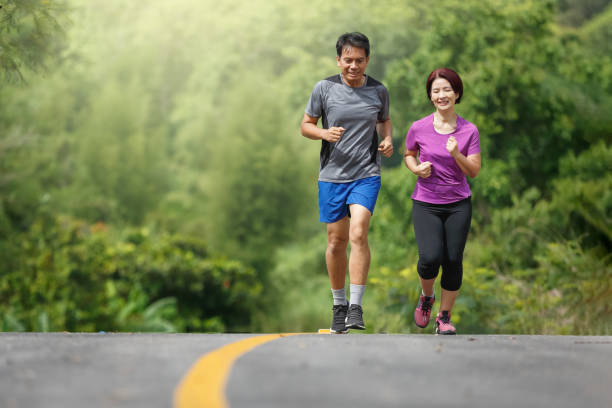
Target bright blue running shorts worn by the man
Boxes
[319,176,380,223]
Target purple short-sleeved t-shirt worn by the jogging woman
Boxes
[406,114,480,204]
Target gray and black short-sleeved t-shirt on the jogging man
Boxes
[306,74,389,183]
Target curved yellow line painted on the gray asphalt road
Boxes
[174,333,306,408]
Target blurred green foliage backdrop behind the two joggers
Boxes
[0,0,612,335]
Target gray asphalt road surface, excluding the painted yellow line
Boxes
[0,333,612,408]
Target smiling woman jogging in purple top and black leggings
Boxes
[404,68,480,334]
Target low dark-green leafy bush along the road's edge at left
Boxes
[0,217,262,331]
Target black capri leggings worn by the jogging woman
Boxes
[412,197,472,290]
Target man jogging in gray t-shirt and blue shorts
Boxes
[301,32,393,333]
